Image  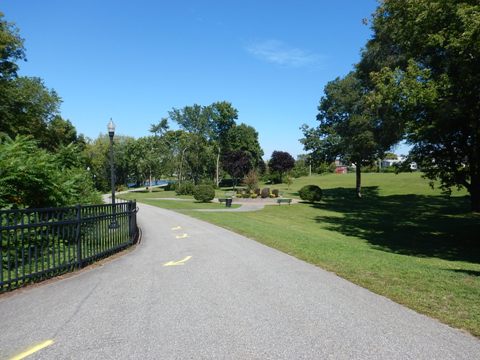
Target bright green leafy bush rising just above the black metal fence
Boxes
[0,136,100,208]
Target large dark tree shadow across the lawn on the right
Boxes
[312,187,480,263]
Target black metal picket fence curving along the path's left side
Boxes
[0,201,138,292]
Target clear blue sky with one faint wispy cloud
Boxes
[0,0,406,158]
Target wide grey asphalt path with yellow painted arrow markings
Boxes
[0,205,480,360]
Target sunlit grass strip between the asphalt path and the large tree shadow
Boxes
[188,204,480,337]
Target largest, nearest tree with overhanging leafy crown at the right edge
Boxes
[358,0,480,211]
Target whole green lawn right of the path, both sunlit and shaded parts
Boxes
[123,173,480,337]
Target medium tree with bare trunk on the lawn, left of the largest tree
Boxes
[300,72,384,198]
